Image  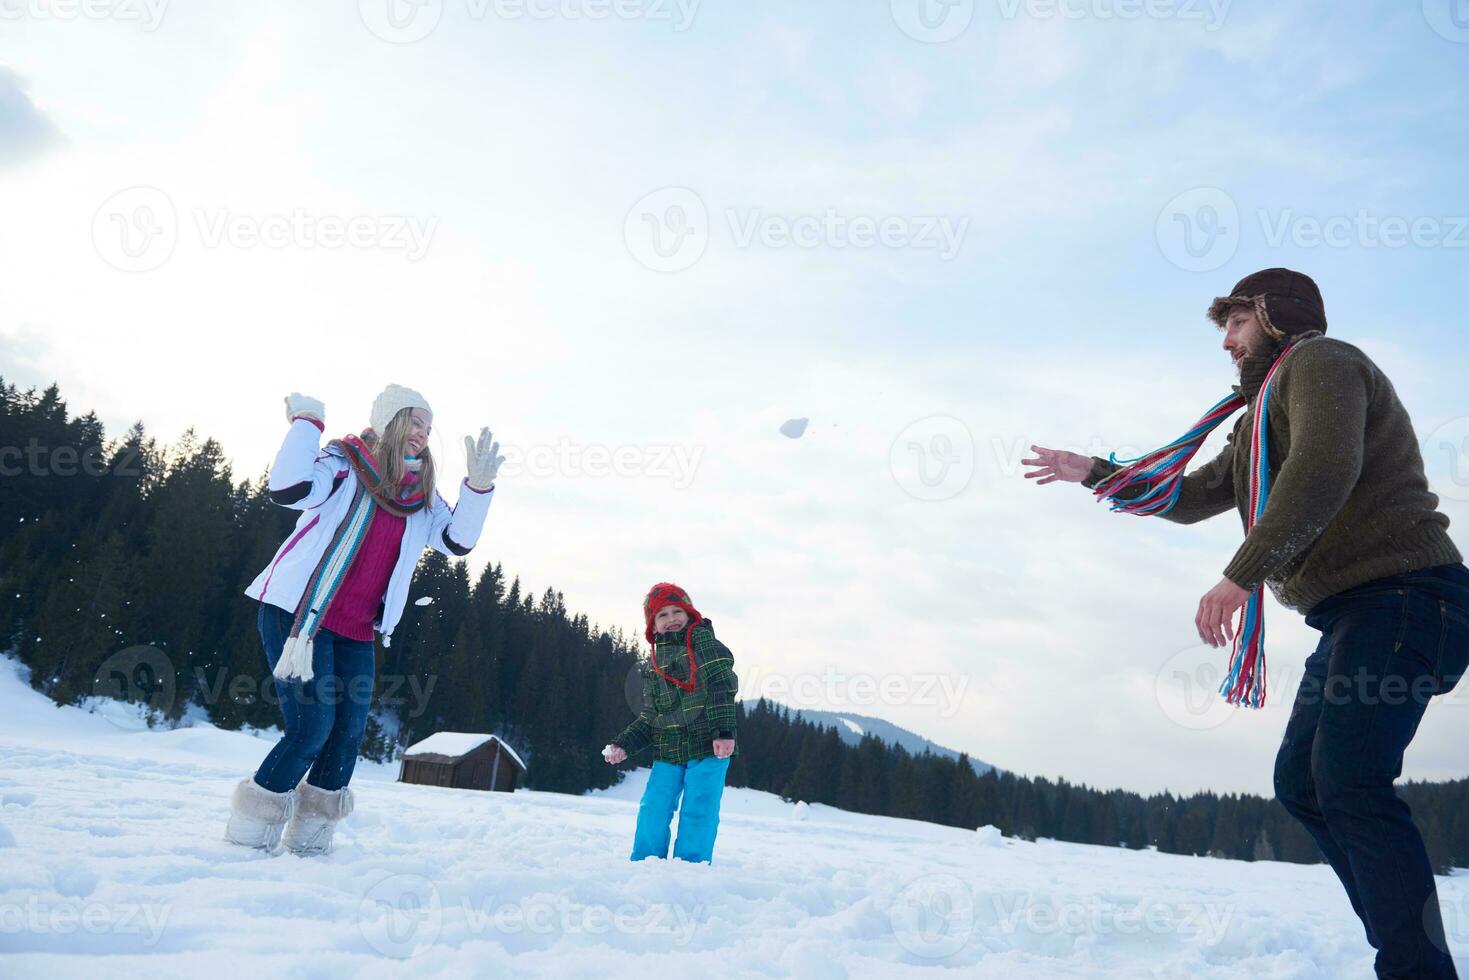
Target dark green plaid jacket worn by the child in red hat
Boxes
[613,620,739,764]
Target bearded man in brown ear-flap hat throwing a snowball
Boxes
[1022,269,1469,977]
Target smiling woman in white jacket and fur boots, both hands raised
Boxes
[225,385,504,854]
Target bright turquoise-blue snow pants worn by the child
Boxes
[633,755,730,864]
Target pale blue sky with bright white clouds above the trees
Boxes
[0,0,1469,792]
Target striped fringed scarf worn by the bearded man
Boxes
[1093,341,1296,708]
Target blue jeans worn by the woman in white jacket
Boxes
[256,602,373,793]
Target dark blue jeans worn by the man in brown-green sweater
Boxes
[1275,564,1469,979]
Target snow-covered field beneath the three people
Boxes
[0,660,1469,980]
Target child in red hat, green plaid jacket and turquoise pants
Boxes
[604,582,739,862]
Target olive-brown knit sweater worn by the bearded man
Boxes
[1084,331,1463,611]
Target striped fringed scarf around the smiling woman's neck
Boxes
[275,429,426,683]
